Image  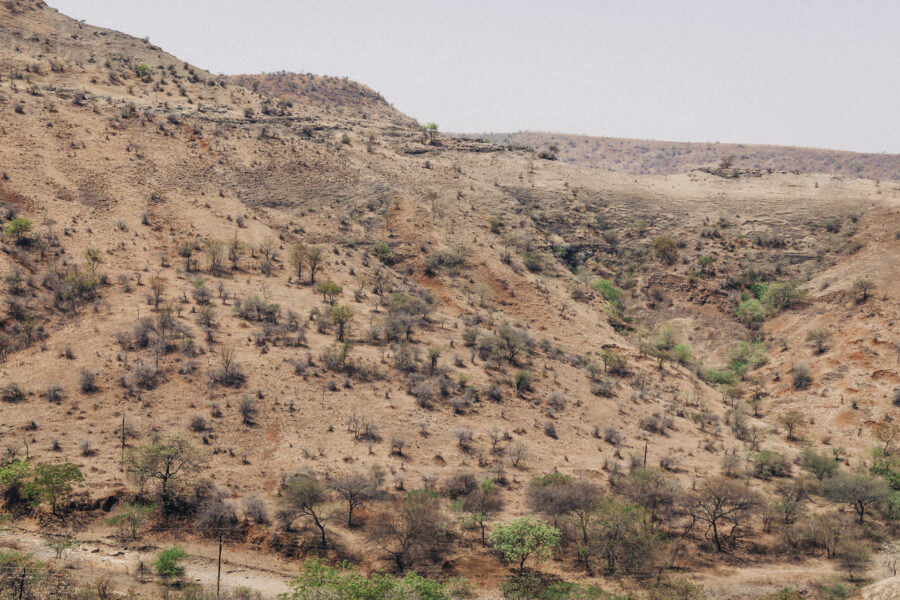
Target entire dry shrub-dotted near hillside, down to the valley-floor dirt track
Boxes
[0,0,900,598]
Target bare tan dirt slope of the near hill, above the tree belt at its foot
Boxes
[0,0,900,591]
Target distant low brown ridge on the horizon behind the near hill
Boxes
[471,131,900,181]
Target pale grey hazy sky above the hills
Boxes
[49,0,900,152]
